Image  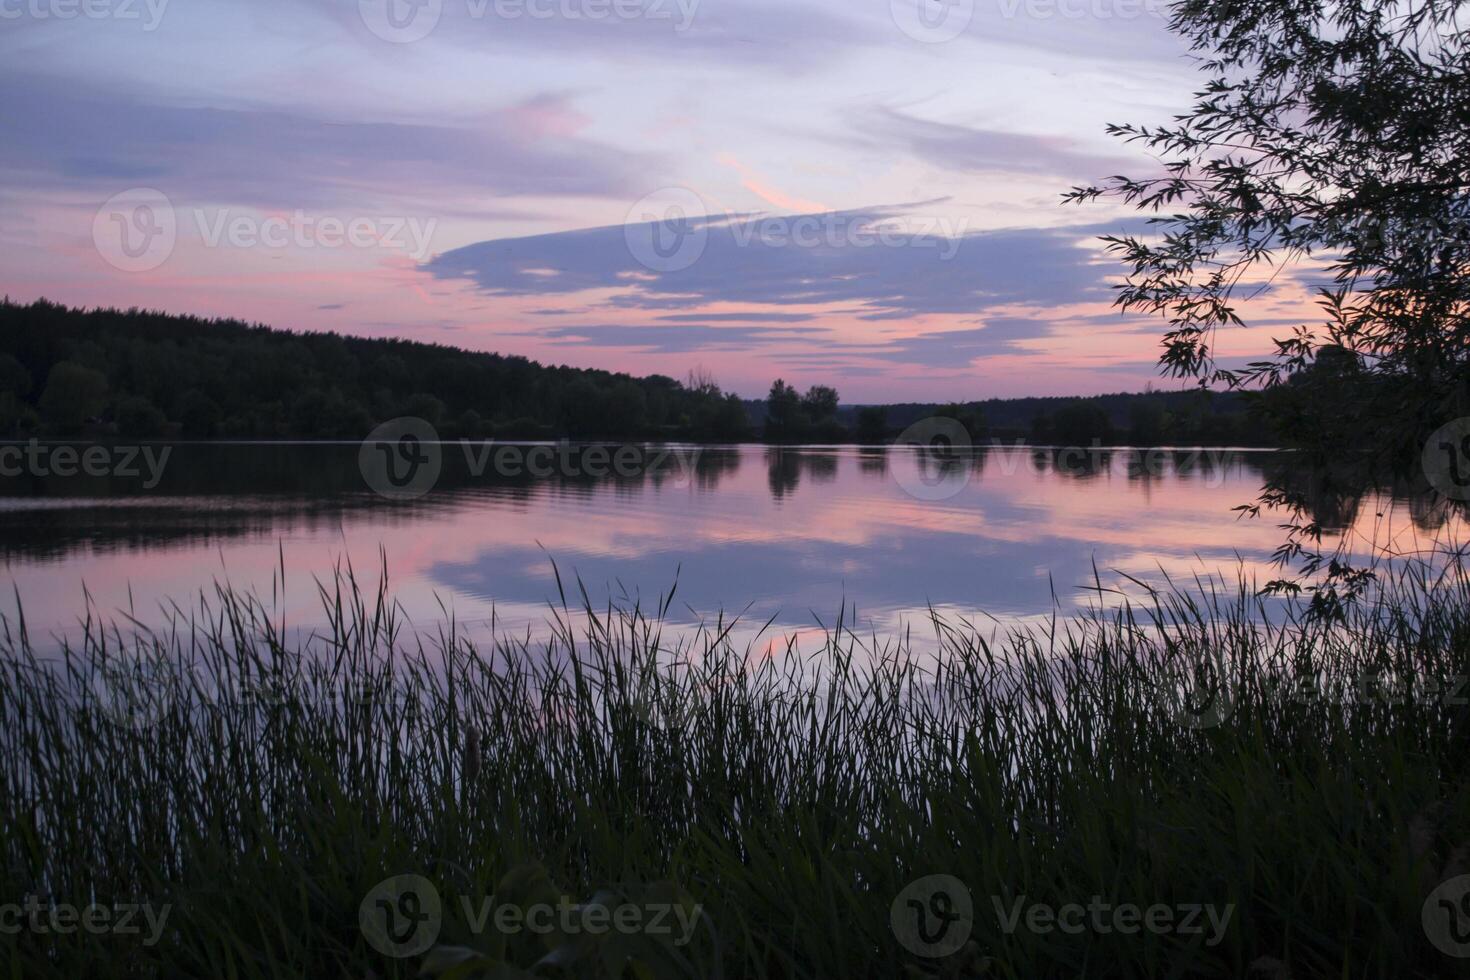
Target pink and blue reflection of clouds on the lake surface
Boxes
[0,447,1458,652]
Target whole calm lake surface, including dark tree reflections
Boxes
[0,442,1446,652]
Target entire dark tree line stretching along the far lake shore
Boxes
[0,300,1287,445]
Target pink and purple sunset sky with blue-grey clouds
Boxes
[0,0,1310,403]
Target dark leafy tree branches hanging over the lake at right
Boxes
[1067,0,1470,605]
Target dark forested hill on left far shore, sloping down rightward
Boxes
[0,300,750,442]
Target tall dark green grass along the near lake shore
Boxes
[0,558,1470,977]
